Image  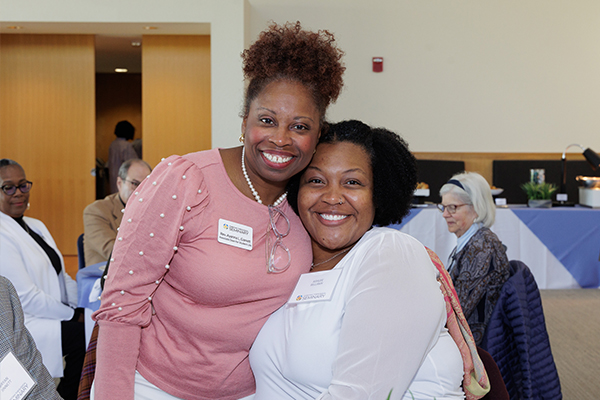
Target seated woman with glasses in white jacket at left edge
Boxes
[0,159,85,400]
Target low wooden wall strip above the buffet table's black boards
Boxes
[414,152,584,184]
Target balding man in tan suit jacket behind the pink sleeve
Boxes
[83,159,152,265]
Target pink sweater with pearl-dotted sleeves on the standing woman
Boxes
[94,149,312,400]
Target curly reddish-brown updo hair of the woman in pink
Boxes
[242,21,346,122]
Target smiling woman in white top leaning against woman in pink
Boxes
[250,121,465,400]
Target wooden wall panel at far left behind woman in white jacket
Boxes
[0,34,95,254]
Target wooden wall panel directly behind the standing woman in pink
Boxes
[142,35,211,166]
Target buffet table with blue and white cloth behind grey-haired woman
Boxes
[391,206,600,289]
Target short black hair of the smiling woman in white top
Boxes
[288,120,417,226]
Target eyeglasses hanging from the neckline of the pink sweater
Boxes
[266,206,292,274]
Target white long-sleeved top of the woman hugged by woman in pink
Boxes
[250,228,464,400]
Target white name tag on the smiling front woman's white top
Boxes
[288,269,342,304]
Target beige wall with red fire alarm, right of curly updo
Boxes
[250,0,600,153]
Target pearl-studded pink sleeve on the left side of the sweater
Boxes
[93,156,208,400]
